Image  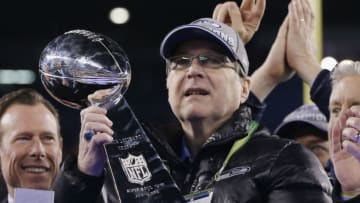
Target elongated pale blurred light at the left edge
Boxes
[0,69,36,85]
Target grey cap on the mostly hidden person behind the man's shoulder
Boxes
[274,104,328,140]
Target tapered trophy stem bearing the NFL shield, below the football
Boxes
[104,98,185,203]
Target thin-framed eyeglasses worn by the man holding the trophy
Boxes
[166,54,244,76]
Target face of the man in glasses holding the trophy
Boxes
[167,40,250,121]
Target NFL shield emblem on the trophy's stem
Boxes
[119,154,152,185]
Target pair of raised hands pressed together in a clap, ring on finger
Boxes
[251,0,321,101]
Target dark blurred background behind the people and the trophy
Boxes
[0,0,360,158]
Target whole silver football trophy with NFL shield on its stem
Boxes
[39,30,184,203]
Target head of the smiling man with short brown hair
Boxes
[0,104,62,195]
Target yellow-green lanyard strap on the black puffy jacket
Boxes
[214,121,259,181]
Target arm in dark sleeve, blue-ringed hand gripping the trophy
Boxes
[54,106,113,203]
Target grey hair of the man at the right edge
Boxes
[331,60,360,86]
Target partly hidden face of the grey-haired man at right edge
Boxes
[329,75,360,138]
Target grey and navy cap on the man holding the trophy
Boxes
[160,18,249,75]
